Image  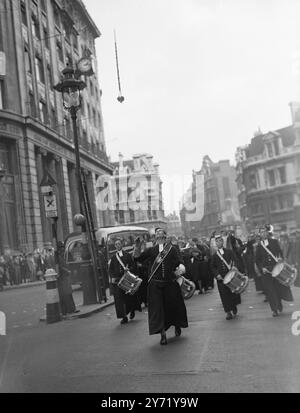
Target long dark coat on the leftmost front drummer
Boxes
[108,251,141,318]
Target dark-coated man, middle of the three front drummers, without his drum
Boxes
[211,234,241,320]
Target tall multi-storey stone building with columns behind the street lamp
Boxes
[0,0,112,252]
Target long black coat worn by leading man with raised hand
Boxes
[135,245,188,335]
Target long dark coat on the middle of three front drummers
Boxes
[211,248,241,313]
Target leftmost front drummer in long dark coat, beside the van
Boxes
[108,238,142,324]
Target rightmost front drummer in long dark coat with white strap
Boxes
[256,225,294,317]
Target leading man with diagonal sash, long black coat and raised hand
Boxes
[133,228,188,345]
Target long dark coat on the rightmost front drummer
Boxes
[256,238,294,304]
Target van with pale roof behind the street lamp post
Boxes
[65,226,150,284]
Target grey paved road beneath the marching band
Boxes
[0,282,300,393]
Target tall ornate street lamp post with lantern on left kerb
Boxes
[54,66,102,304]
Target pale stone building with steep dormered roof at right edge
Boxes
[236,104,300,232]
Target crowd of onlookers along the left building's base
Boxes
[0,248,54,289]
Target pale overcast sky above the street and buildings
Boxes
[84,0,300,211]
